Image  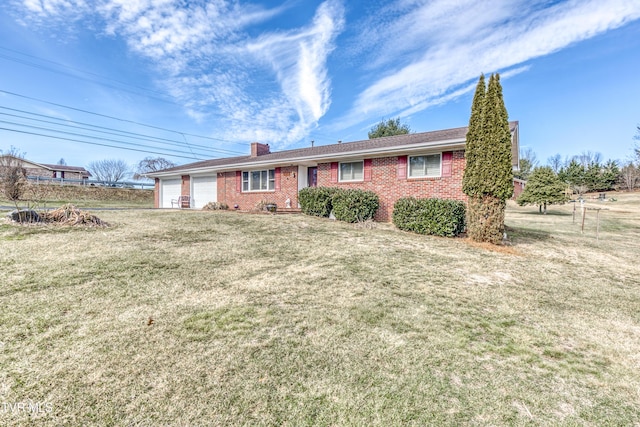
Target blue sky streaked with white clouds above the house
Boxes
[0,0,640,171]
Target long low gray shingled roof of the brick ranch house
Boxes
[149,121,518,176]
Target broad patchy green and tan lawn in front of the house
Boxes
[0,194,640,426]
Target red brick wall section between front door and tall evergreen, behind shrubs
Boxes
[318,151,467,221]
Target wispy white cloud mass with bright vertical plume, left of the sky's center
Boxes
[10,0,344,146]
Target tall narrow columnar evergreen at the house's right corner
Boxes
[462,74,513,244]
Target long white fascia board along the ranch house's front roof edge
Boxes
[147,138,466,178]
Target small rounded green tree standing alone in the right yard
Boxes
[517,166,568,214]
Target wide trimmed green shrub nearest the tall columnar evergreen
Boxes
[393,197,465,237]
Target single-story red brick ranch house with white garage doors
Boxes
[148,121,519,221]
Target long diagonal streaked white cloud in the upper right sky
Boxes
[338,0,640,128]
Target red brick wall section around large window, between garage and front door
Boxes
[218,166,298,210]
